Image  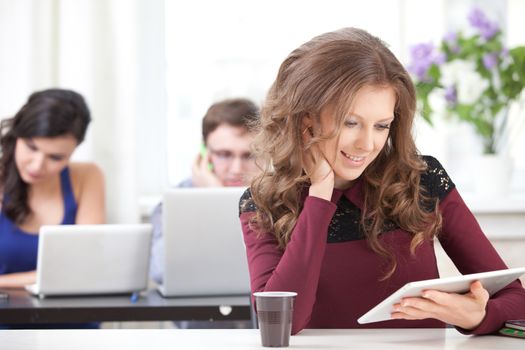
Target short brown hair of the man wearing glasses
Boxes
[202,98,259,143]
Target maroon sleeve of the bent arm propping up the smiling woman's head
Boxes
[240,197,337,334]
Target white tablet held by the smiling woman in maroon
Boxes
[357,267,525,324]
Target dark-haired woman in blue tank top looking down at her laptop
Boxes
[0,89,105,288]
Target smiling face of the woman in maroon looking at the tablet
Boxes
[321,86,396,189]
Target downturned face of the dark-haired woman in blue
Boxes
[15,134,77,185]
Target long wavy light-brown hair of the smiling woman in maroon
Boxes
[251,28,441,278]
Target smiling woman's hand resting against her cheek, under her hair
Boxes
[303,129,335,201]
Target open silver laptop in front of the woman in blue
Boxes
[26,224,152,297]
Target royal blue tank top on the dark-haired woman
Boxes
[0,167,77,275]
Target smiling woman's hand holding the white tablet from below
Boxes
[392,281,489,329]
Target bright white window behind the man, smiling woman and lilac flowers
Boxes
[165,0,525,191]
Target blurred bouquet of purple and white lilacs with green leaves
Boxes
[408,9,525,154]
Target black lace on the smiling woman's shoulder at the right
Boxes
[420,156,456,200]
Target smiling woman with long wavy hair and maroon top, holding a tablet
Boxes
[239,28,525,334]
